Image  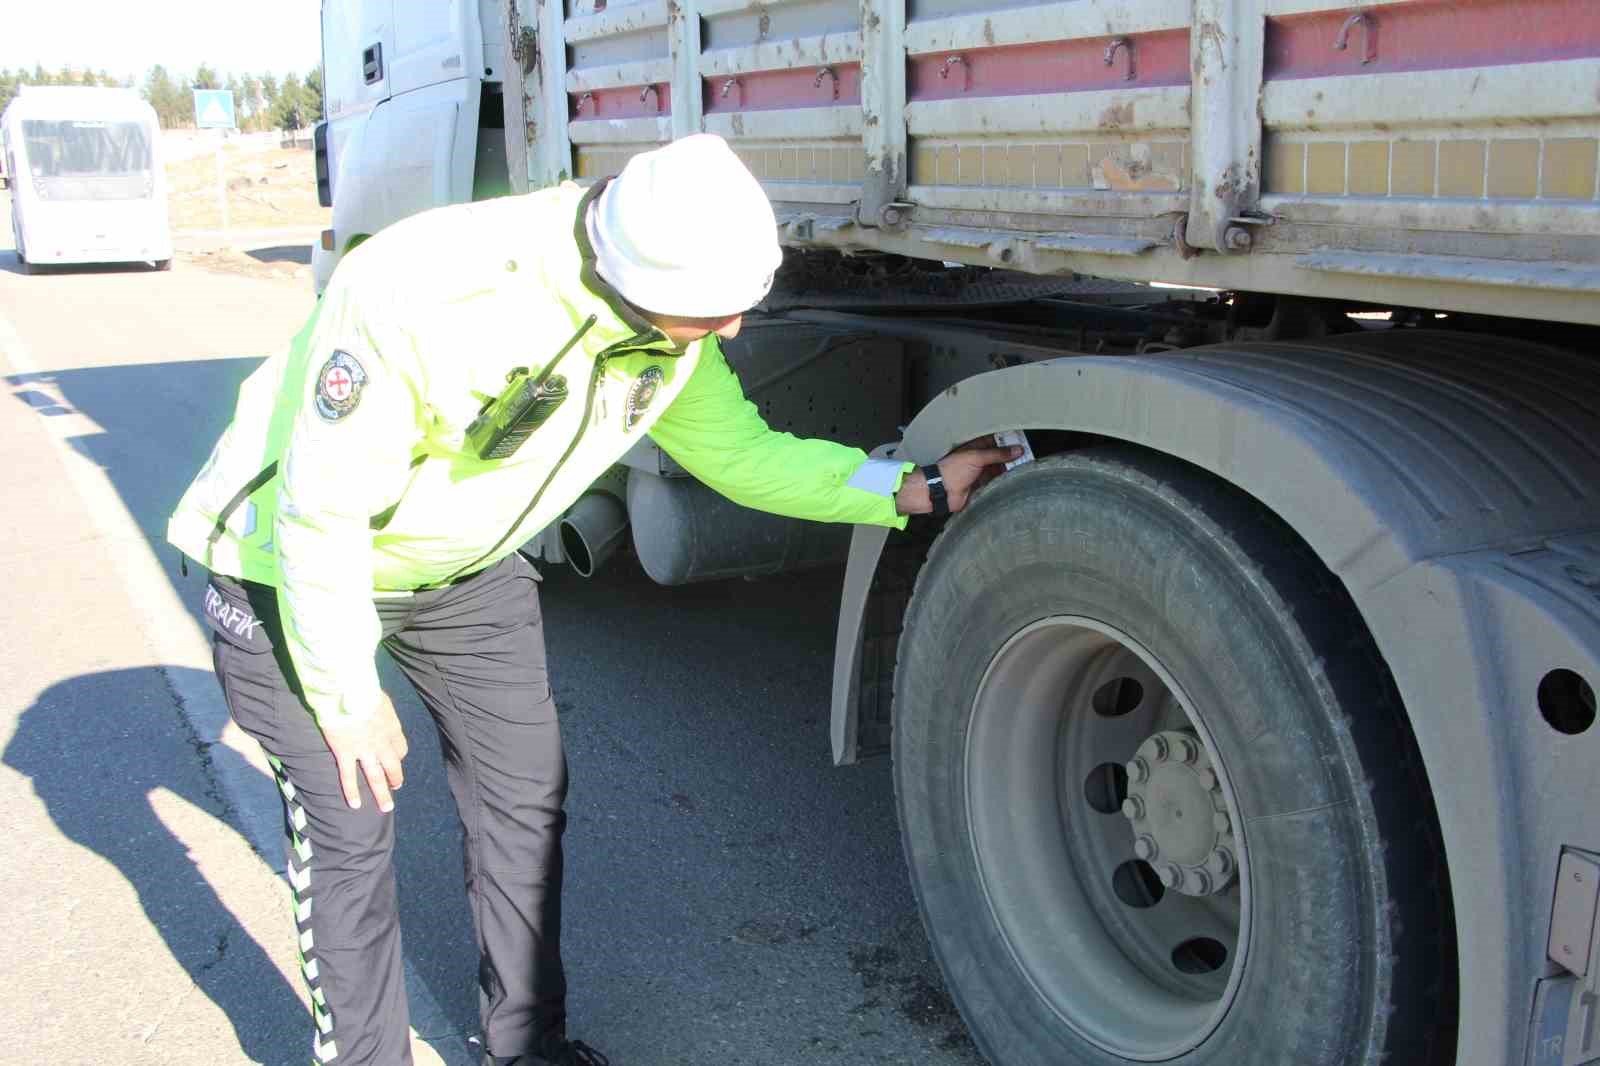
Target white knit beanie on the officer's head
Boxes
[589,133,782,319]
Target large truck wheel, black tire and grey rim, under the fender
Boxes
[893,448,1456,1066]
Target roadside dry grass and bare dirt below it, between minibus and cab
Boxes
[166,146,333,287]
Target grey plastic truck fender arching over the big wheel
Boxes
[832,330,1600,1064]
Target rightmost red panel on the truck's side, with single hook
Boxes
[1266,0,1600,82]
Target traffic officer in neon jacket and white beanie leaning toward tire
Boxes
[168,134,1010,1066]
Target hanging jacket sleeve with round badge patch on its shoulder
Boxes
[274,281,422,799]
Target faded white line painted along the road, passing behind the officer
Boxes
[0,305,478,1066]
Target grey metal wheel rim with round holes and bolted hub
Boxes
[963,616,1250,1061]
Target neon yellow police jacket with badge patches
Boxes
[166,184,910,717]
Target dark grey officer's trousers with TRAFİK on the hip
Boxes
[205,554,566,1066]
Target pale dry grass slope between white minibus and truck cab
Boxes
[166,147,333,230]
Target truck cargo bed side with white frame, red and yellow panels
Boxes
[507,0,1600,323]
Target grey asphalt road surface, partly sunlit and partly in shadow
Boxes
[0,217,981,1066]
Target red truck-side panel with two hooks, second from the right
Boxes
[906,30,1189,101]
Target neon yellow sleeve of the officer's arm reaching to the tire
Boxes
[650,336,909,528]
